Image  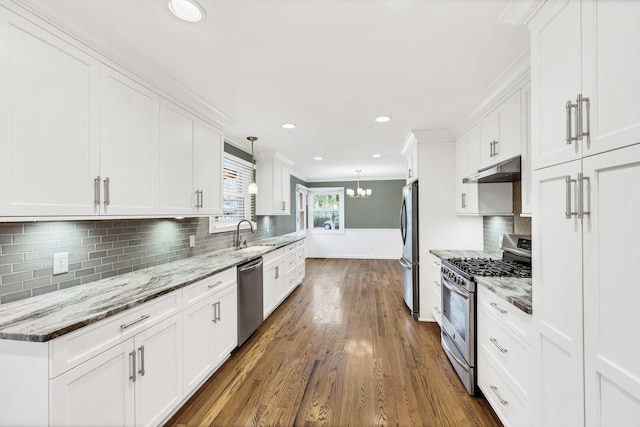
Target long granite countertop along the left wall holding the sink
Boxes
[0,236,304,342]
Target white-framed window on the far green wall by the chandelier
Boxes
[308,187,345,234]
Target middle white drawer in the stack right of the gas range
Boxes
[477,309,532,394]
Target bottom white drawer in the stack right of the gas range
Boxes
[478,353,533,427]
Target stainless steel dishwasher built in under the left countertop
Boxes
[238,257,264,347]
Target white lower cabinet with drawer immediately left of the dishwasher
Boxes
[182,269,238,395]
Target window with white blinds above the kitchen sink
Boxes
[209,153,254,233]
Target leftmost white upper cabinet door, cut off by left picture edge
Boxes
[0,9,98,216]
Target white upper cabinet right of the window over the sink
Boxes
[256,152,293,215]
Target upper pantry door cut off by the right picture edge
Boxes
[582,0,640,155]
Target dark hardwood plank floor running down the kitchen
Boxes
[168,259,501,426]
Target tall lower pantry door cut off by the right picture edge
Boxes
[584,145,640,426]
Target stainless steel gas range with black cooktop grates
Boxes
[441,234,531,395]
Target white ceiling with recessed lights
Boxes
[23,0,529,181]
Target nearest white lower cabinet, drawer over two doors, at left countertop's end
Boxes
[50,314,183,426]
